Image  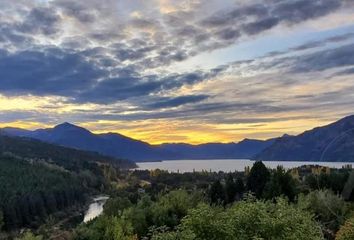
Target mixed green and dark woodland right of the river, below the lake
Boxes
[4,159,354,240]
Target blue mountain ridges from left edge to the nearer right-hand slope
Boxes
[1,123,274,161]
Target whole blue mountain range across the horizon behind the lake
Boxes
[0,115,354,162]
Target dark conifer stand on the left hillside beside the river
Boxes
[0,156,86,230]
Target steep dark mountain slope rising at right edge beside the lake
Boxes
[254,115,354,162]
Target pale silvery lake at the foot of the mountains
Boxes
[137,159,350,172]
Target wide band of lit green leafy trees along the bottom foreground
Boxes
[72,190,323,240]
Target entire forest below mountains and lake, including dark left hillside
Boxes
[0,137,354,240]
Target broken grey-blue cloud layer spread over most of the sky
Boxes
[0,0,354,142]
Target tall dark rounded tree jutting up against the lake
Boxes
[247,161,270,198]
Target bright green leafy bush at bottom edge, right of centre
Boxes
[153,199,323,240]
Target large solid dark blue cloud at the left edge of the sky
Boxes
[0,49,106,97]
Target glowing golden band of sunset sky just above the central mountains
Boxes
[80,118,329,144]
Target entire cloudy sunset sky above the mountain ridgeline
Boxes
[0,0,354,144]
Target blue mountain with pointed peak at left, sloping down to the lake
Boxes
[3,123,170,161]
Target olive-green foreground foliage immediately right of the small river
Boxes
[74,190,202,240]
